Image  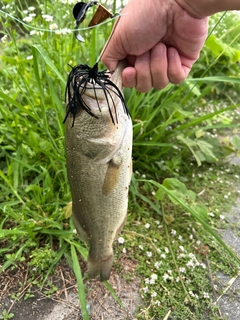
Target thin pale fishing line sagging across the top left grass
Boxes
[0,10,126,33]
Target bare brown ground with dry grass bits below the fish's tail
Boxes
[0,259,140,320]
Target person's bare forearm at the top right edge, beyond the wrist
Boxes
[175,0,240,18]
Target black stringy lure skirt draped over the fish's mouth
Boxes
[63,62,129,127]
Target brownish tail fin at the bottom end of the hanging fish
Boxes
[87,254,113,281]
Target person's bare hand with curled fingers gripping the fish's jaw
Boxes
[102,0,208,92]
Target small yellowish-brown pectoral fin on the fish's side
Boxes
[102,156,122,196]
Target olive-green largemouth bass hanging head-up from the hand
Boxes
[66,63,132,281]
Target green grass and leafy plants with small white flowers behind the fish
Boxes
[0,0,240,320]
